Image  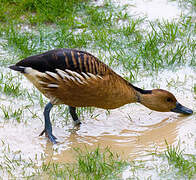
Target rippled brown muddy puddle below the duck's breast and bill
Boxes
[47,108,192,162]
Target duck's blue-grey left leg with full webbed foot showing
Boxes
[40,102,57,144]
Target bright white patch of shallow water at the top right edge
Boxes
[112,0,193,20]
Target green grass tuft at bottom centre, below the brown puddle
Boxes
[77,148,127,180]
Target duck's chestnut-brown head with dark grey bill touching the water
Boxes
[140,89,193,115]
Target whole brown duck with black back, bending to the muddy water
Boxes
[9,49,193,143]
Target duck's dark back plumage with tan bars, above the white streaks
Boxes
[16,49,110,75]
